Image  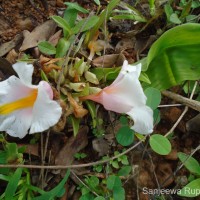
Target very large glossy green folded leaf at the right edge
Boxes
[146,23,200,90]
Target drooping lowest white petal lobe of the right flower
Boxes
[126,106,153,134]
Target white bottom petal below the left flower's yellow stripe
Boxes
[0,108,32,138]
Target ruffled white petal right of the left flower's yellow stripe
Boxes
[30,81,62,134]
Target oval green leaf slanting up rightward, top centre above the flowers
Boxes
[72,16,99,34]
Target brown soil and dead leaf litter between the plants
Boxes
[0,0,200,200]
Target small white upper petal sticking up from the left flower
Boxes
[13,62,33,85]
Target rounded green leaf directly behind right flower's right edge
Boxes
[144,87,161,110]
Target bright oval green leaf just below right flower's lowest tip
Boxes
[149,134,171,155]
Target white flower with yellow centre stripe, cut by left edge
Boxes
[0,62,62,138]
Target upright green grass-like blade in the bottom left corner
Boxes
[5,168,22,200]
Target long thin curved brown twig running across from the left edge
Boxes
[0,141,142,169]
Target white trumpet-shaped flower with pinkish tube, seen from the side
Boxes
[81,60,153,134]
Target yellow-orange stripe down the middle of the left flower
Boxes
[0,89,38,115]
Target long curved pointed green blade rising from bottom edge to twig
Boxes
[33,170,70,200]
